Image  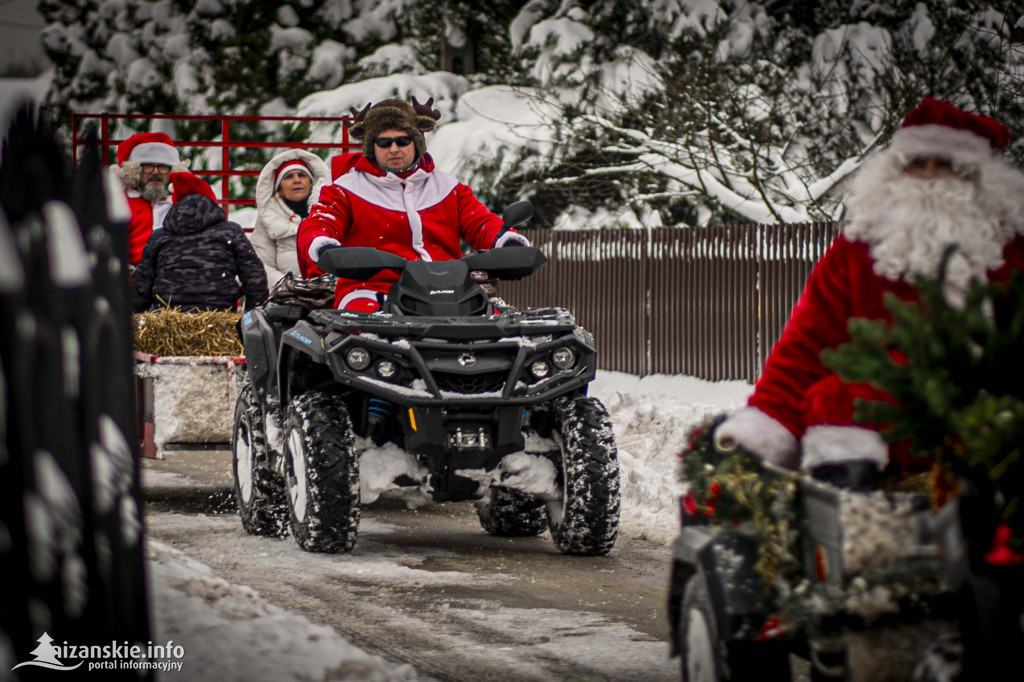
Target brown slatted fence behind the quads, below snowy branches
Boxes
[499,222,839,381]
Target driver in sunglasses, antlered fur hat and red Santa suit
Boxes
[298,97,529,312]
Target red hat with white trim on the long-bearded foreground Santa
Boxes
[890,97,1010,164]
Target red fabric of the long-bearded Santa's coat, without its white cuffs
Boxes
[749,231,1024,468]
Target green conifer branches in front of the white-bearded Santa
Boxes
[821,252,1024,537]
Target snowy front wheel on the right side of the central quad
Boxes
[548,396,620,555]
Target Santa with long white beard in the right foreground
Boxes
[715,98,1024,488]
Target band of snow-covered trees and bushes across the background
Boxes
[40,0,1024,227]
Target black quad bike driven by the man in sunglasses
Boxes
[232,202,620,555]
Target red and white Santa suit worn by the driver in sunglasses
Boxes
[298,154,504,308]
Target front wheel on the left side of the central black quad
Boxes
[285,391,359,552]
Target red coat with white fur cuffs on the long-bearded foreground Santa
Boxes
[716,231,1024,470]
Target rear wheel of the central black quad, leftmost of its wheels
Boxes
[231,381,288,537]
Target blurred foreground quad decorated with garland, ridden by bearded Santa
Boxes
[668,425,957,682]
